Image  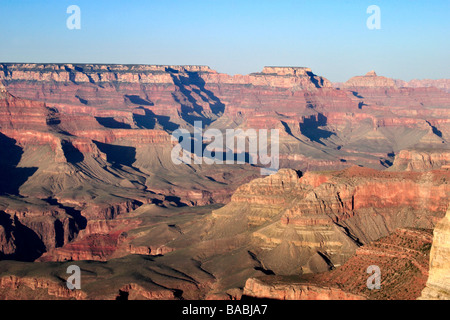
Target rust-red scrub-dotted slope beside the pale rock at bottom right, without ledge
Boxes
[310,228,432,300]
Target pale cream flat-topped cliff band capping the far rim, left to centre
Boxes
[0,63,331,88]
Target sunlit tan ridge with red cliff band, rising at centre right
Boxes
[205,167,450,274]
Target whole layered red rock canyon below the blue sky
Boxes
[0,63,450,300]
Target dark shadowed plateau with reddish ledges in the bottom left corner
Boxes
[0,255,211,300]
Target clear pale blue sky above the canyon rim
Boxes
[0,0,450,81]
